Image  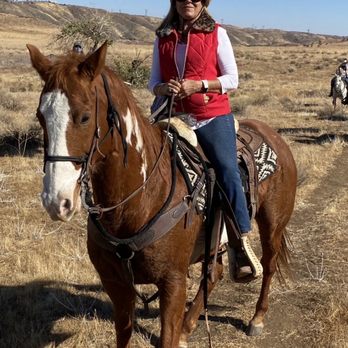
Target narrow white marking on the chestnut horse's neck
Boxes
[123,109,147,182]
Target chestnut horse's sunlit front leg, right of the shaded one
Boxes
[158,272,186,348]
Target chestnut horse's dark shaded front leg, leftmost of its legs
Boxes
[102,279,135,348]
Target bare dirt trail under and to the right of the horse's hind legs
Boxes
[186,147,348,348]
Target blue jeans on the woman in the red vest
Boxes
[195,114,251,233]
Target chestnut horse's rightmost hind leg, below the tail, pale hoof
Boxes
[247,208,288,336]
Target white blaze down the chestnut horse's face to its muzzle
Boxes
[40,90,81,221]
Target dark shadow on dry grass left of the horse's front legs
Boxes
[0,281,112,348]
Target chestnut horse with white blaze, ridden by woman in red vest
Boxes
[27,44,297,347]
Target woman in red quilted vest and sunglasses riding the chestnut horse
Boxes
[149,0,262,279]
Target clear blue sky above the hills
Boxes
[57,0,348,36]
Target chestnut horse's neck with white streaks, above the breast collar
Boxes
[93,84,170,234]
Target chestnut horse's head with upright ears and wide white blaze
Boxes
[27,44,106,221]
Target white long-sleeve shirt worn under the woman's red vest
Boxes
[148,26,238,93]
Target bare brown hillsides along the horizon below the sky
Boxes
[0,0,347,46]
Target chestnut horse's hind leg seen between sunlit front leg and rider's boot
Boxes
[180,256,223,347]
